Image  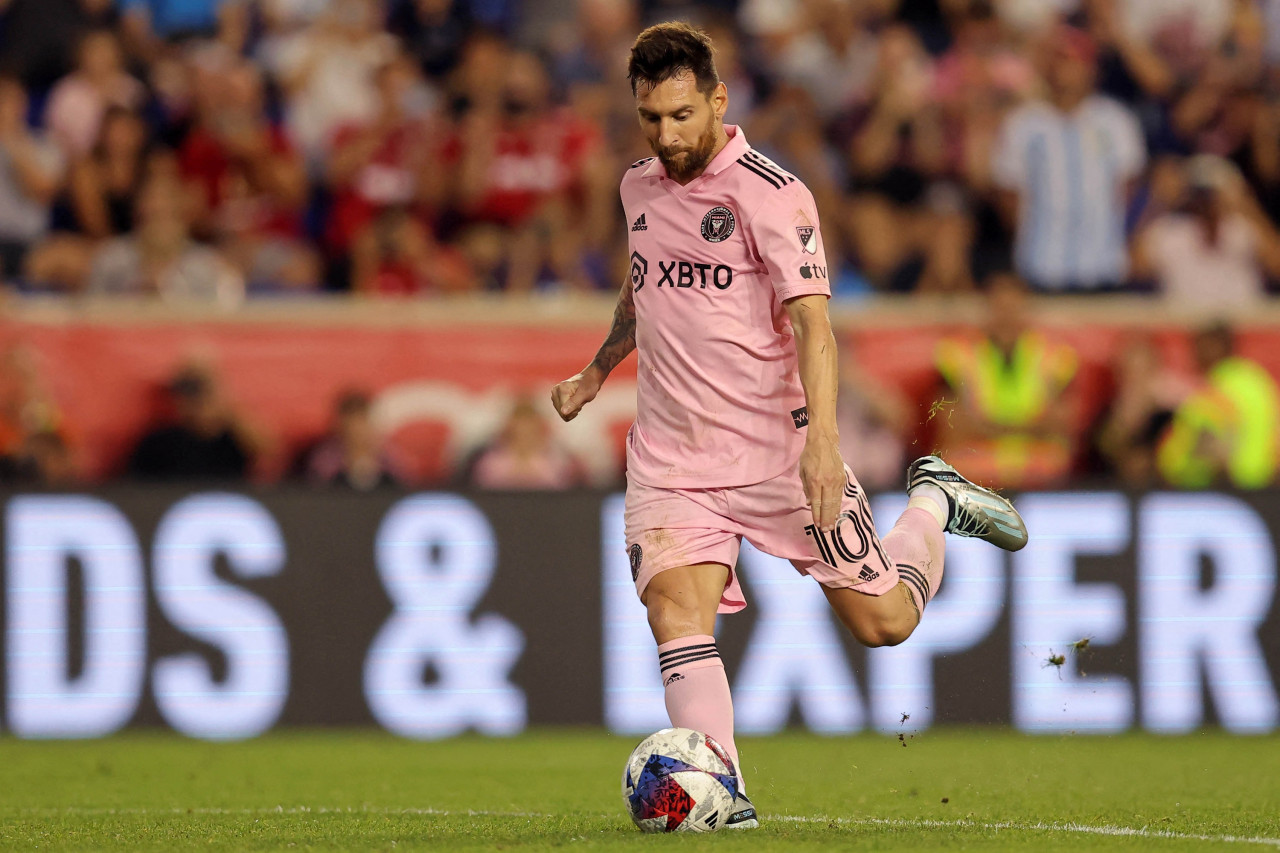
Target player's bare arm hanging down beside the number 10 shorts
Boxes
[786,293,845,530]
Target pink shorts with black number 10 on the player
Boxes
[625,465,897,613]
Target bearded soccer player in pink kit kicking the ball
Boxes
[552,23,1027,829]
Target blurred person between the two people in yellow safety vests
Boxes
[1093,337,1194,488]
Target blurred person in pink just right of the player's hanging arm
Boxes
[836,338,911,492]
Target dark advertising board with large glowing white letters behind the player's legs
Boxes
[0,487,1280,739]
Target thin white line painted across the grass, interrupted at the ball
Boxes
[10,806,1280,848]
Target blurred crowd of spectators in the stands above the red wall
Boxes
[0,0,1280,298]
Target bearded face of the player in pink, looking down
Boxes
[636,72,728,182]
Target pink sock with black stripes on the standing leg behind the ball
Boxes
[658,634,742,779]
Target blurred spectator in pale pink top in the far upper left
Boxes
[45,29,146,160]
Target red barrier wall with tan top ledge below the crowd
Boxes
[15,296,1280,485]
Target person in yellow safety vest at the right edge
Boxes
[1156,324,1280,489]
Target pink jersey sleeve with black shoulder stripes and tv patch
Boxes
[750,181,831,302]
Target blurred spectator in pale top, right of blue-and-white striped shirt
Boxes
[1133,154,1280,303]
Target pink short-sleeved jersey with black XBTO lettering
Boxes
[622,126,831,489]
